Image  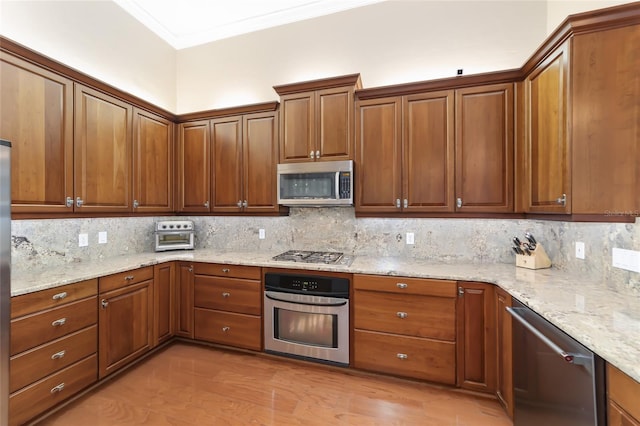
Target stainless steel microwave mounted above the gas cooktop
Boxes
[278,160,353,207]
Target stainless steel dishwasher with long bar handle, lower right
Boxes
[507,300,606,426]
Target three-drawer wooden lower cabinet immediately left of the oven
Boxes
[193,263,262,351]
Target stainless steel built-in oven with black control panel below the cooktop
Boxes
[264,273,350,366]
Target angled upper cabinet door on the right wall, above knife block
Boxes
[524,42,573,213]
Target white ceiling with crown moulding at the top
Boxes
[113,0,384,49]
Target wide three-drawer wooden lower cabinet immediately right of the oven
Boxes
[353,275,456,385]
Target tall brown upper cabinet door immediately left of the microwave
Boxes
[242,112,279,213]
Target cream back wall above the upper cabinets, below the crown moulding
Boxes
[177,0,547,113]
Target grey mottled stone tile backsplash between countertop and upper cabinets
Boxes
[11,207,640,289]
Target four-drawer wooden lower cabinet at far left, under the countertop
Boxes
[9,279,98,426]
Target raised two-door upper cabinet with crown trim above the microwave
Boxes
[274,74,361,163]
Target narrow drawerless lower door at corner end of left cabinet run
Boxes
[153,262,176,346]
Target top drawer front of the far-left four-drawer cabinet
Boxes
[11,279,98,319]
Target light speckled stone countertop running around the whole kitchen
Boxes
[11,250,640,382]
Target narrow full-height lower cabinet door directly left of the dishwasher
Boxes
[495,287,513,418]
